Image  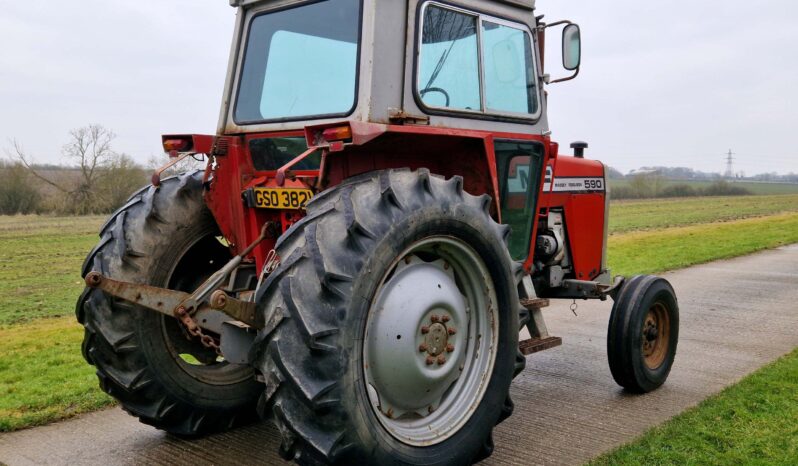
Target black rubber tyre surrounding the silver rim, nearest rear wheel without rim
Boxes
[253,169,528,465]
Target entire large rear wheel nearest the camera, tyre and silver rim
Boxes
[254,170,524,465]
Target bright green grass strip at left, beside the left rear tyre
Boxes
[0,316,114,432]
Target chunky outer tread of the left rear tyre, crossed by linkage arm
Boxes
[75,171,255,436]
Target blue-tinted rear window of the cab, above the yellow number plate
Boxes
[233,0,361,124]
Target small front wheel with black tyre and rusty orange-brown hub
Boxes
[607,275,679,393]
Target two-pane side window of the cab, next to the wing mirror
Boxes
[416,2,539,118]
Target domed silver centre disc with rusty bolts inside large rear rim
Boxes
[368,256,468,417]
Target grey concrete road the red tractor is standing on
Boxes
[0,245,798,466]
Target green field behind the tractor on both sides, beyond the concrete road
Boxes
[0,195,798,448]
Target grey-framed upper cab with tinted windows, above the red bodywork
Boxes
[219,0,548,134]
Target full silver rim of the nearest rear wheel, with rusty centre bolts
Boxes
[363,236,499,446]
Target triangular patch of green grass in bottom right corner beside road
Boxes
[589,349,798,466]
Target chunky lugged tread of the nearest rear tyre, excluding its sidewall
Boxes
[254,169,526,464]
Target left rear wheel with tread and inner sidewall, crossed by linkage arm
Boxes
[76,172,263,436]
